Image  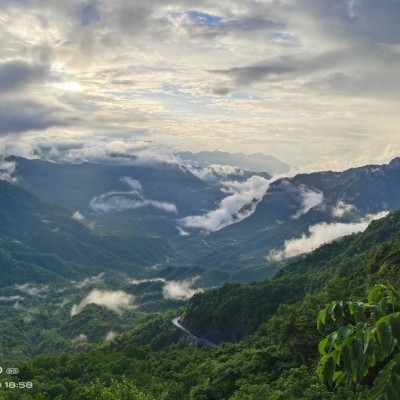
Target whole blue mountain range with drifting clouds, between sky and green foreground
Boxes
[0,157,400,287]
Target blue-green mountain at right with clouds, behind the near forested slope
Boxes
[191,159,400,272]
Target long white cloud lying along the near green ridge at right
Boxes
[267,211,388,261]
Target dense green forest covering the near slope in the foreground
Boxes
[0,208,400,400]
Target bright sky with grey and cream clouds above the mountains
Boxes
[0,0,400,169]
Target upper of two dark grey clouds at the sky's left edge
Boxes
[0,60,49,93]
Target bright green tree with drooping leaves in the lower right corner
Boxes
[317,284,400,400]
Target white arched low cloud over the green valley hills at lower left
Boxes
[71,289,136,317]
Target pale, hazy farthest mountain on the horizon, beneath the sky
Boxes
[177,150,290,175]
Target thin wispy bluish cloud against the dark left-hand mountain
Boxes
[89,177,178,214]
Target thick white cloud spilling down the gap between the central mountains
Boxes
[179,176,270,232]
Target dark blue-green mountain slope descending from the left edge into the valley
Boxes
[0,181,177,285]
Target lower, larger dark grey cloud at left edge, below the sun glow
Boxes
[0,100,78,135]
